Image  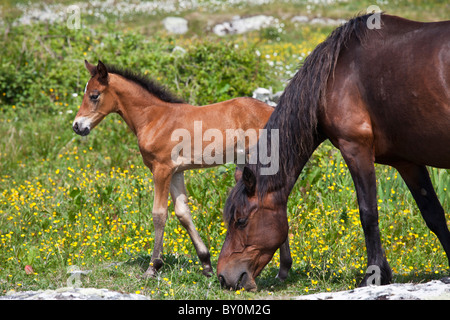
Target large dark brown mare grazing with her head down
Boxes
[217,15,450,290]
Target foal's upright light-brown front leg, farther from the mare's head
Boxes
[143,167,172,278]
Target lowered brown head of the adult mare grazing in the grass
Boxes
[217,166,289,291]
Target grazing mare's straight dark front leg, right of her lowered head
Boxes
[339,141,392,286]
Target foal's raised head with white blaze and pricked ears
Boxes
[73,60,116,136]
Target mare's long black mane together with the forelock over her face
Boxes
[224,15,370,222]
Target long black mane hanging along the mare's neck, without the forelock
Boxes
[266,15,369,176]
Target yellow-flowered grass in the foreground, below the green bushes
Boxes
[0,109,449,299]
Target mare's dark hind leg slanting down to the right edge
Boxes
[396,163,450,265]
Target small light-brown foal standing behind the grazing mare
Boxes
[73,61,273,277]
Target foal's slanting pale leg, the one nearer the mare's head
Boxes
[170,172,214,277]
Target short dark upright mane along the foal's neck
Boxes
[98,64,184,103]
